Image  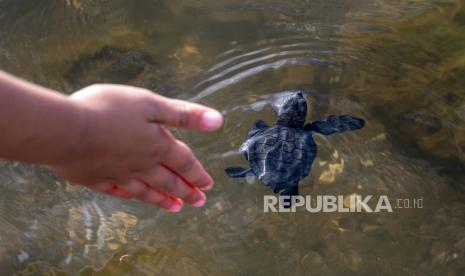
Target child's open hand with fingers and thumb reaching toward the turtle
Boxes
[50,84,223,212]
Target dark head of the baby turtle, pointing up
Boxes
[276,91,307,127]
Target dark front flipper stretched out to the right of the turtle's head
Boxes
[304,115,365,135]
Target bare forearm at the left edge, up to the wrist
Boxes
[0,72,95,164]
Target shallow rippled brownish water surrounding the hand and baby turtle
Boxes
[0,0,465,275]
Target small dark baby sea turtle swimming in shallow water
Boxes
[225,91,365,201]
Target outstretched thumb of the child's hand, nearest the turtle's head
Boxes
[151,95,223,131]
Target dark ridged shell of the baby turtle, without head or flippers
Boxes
[246,125,316,192]
